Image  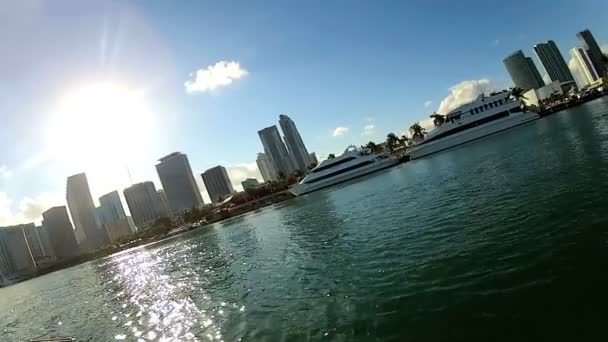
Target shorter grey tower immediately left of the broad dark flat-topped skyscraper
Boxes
[124,181,166,229]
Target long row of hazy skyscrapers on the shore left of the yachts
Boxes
[0,115,317,285]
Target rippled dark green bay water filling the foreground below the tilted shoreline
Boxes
[0,99,608,341]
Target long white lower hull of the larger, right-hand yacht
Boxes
[407,112,540,159]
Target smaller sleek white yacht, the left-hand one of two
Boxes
[289,146,399,196]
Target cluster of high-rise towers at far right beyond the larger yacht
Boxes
[503,30,608,104]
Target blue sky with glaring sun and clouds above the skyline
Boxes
[0,0,608,225]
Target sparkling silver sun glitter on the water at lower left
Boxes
[105,246,227,342]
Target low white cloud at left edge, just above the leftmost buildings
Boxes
[0,192,65,226]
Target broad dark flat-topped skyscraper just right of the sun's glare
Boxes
[154,152,204,214]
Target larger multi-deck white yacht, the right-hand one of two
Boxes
[407,90,539,159]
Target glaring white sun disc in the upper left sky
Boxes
[49,82,154,162]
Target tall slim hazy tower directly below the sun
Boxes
[66,173,110,251]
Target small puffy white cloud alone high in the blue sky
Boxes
[184,61,248,93]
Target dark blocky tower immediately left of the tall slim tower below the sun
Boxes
[42,206,80,259]
